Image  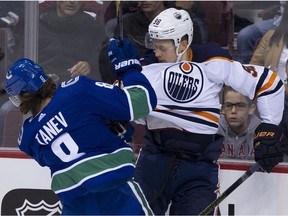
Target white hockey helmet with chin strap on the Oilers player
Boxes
[148,8,193,60]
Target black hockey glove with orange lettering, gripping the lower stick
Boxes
[254,123,286,173]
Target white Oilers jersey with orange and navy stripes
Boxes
[142,59,284,134]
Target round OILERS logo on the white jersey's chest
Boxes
[164,62,204,103]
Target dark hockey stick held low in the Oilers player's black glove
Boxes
[199,163,261,215]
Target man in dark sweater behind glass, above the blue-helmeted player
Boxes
[16,1,105,82]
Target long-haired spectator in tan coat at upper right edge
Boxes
[250,4,288,85]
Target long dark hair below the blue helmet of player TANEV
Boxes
[20,78,56,116]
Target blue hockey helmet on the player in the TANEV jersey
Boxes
[5,58,48,96]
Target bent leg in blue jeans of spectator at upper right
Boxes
[237,1,286,64]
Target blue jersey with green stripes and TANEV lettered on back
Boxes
[18,72,156,200]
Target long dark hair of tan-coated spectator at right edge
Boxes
[269,3,288,47]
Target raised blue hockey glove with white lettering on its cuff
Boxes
[108,38,142,76]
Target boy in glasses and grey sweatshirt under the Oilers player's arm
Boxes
[218,86,261,160]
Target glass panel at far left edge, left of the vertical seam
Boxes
[0,1,24,149]
